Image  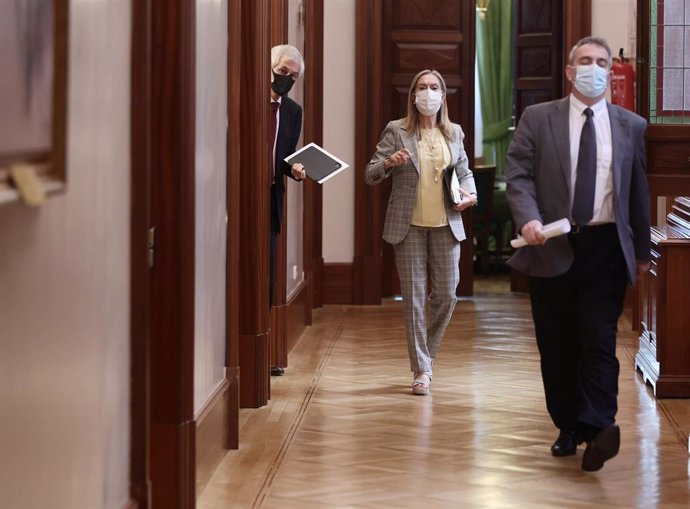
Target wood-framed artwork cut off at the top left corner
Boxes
[0,0,68,203]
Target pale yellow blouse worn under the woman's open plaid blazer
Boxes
[410,128,450,227]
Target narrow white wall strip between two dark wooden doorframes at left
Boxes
[194,0,228,413]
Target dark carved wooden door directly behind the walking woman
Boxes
[354,0,475,304]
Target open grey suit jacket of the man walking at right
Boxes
[505,96,650,284]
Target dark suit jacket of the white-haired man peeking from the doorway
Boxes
[271,96,302,233]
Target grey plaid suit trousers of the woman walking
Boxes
[393,226,460,372]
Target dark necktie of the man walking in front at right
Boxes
[573,108,597,226]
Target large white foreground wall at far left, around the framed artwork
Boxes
[0,0,131,509]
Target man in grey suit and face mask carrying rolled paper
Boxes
[505,37,650,471]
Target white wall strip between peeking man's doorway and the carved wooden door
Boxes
[323,0,354,263]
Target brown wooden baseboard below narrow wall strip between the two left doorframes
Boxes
[195,376,231,497]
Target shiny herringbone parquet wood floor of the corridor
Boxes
[198,286,690,509]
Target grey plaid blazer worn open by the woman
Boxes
[365,120,477,244]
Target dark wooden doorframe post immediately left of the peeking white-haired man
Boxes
[236,0,271,408]
